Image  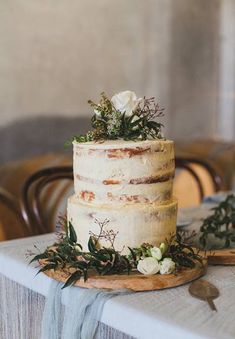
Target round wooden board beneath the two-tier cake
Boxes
[40,261,207,292]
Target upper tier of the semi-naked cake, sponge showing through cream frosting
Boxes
[73,140,175,205]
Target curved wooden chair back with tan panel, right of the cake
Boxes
[174,157,223,207]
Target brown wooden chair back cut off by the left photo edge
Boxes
[0,187,28,240]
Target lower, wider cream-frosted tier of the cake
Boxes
[67,195,177,254]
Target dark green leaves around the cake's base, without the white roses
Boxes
[31,221,203,288]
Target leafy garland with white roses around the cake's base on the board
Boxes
[31,219,203,288]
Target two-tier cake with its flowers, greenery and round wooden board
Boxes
[32,91,205,291]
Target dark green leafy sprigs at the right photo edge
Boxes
[200,194,235,248]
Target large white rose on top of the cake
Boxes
[111,91,142,116]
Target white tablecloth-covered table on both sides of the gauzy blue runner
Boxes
[0,234,235,339]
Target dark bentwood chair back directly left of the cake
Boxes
[21,166,73,234]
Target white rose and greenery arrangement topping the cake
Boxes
[65,91,164,145]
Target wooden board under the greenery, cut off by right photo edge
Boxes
[203,248,235,265]
